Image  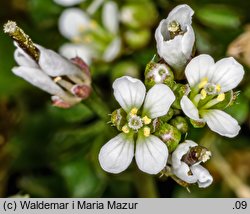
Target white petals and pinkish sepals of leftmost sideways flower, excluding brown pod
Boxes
[12,43,90,107]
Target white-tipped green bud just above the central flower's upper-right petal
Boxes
[145,61,174,88]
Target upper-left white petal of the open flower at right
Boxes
[185,54,214,87]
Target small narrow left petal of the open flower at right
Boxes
[180,95,204,122]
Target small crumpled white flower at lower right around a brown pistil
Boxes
[172,140,213,188]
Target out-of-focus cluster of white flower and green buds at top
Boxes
[54,0,157,64]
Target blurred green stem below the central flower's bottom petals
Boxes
[134,171,158,198]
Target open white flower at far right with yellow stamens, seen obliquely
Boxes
[181,54,244,137]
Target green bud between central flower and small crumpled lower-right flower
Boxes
[155,123,181,152]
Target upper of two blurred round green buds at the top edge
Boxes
[121,1,158,29]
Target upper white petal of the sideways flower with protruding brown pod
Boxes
[37,46,82,77]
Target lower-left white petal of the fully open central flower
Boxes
[99,133,134,173]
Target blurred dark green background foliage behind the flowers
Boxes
[0,0,250,197]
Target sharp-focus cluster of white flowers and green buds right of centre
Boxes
[99,5,244,188]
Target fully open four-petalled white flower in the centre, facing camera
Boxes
[99,76,175,174]
